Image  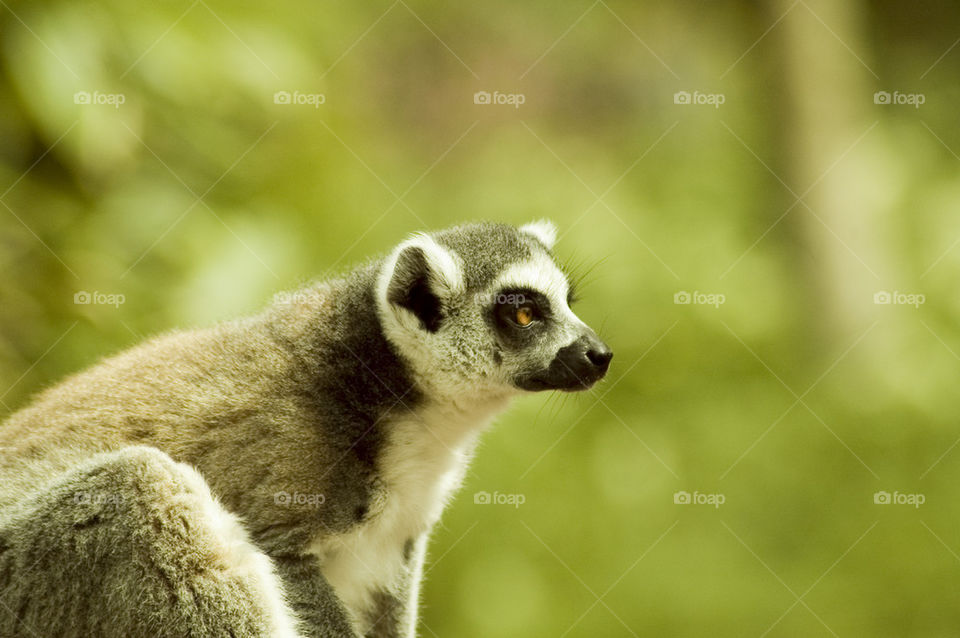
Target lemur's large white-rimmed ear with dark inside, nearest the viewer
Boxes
[386,235,463,332]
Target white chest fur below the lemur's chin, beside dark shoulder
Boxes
[310,406,506,635]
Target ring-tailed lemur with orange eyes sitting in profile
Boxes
[0,222,612,638]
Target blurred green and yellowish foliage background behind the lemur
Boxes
[0,0,960,638]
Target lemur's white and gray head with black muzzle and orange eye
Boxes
[377,221,613,396]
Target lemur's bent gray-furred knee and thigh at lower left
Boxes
[0,446,332,637]
